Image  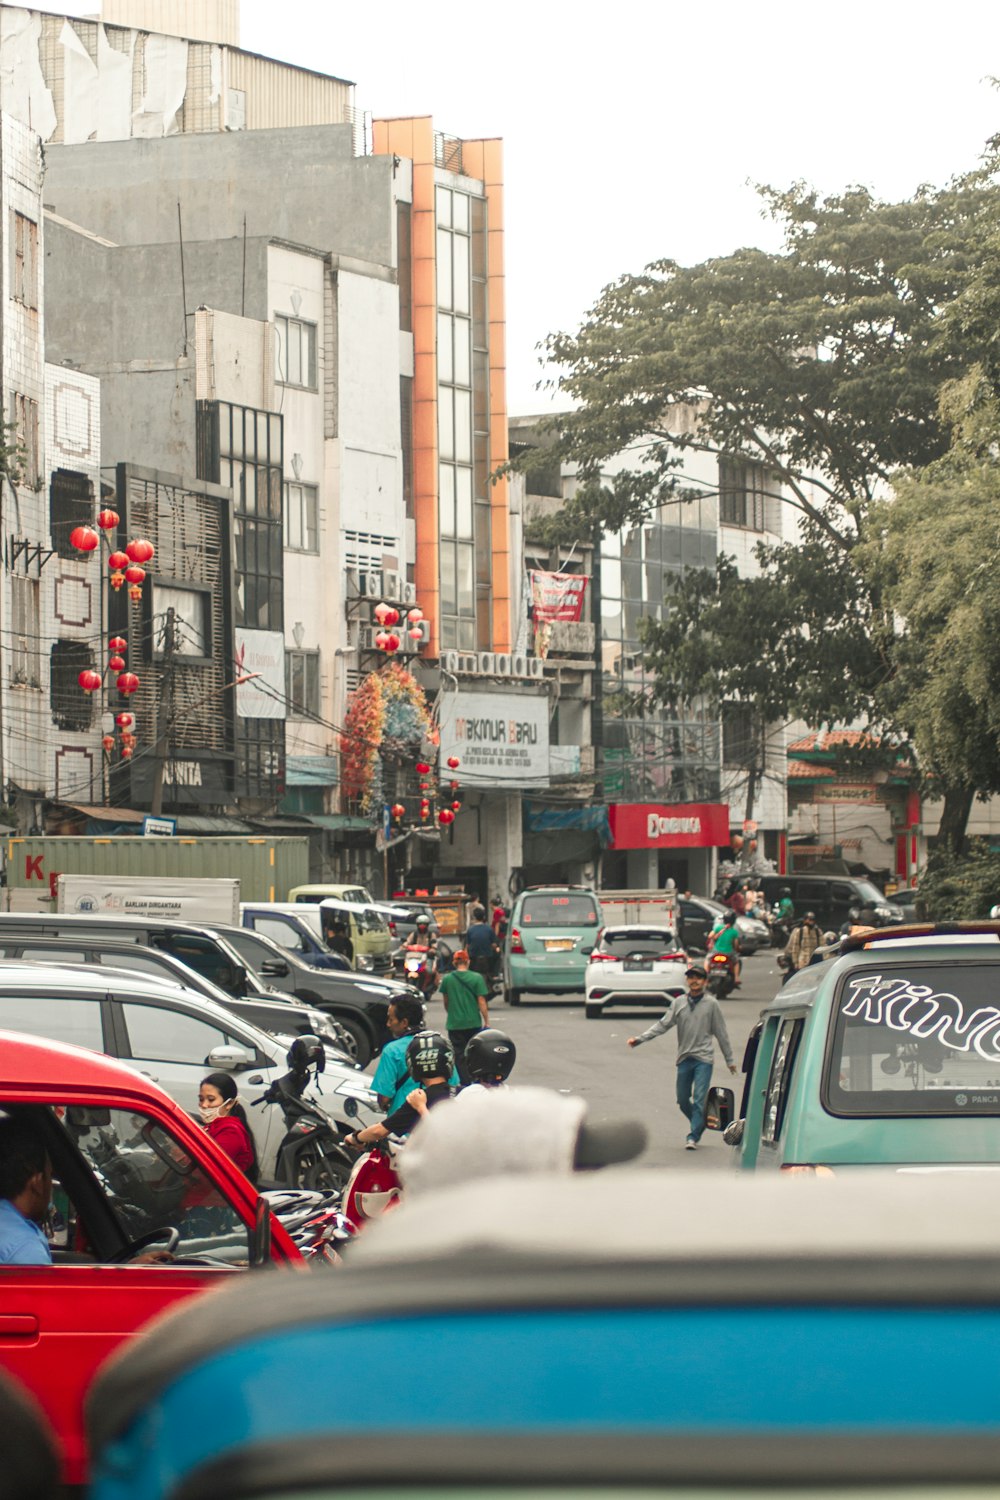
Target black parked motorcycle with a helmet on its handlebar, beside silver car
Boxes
[252,1037,352,1191]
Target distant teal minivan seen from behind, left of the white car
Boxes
[504,885,601,1005]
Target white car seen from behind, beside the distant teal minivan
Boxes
[583,923,688,1022]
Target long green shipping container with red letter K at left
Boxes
[6,834,309,911]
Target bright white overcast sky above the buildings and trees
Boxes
[60,0,1000,414]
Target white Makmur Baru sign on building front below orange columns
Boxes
[439,693,549,789]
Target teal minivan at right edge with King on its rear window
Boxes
[717,923,1000,1172]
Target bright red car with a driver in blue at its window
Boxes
[0,1031,301,1484]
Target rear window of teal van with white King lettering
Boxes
[826,950,1000,1115]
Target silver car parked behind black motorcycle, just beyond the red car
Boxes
[0,963,381,1178]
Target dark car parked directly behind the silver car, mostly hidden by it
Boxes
[0,935,354,1065]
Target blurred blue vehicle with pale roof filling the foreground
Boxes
[88,1169,1000,1500]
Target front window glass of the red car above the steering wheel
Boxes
[57,1106,249,1265]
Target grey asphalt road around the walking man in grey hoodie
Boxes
[427,948,781,1172]
